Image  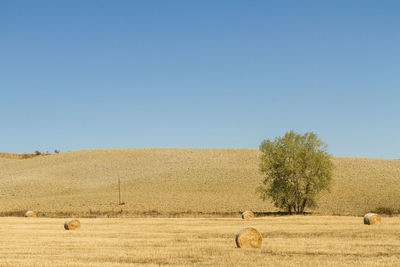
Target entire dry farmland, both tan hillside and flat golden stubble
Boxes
[0,149,400,266]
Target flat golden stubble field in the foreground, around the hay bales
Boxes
[0,216,400,266]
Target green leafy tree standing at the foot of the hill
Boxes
[257,131,333,213]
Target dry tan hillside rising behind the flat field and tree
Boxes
[0,149,400,217]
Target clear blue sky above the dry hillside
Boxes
[0,0,400,158]
